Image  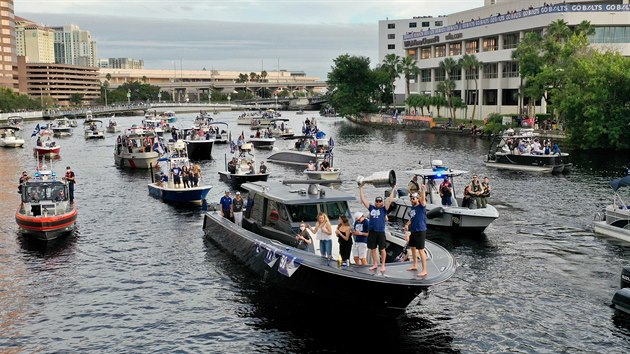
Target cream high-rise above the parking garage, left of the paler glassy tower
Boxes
[15,16,55,63]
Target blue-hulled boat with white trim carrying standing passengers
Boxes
[148,140,212,204]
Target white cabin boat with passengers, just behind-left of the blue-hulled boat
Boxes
[114,124,161,169]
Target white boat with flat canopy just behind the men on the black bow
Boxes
[387,160,499,233]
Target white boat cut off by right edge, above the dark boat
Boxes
[593,176,630,242]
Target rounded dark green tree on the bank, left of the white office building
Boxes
[326,54,381,116]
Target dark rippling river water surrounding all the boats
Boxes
[0,112,630,353]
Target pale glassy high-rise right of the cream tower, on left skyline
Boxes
[53,25,97,67]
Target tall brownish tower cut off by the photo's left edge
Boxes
[0,0,18,90]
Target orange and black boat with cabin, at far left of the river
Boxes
[15,165,77,240]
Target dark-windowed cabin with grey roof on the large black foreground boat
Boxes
[241,181,356,255]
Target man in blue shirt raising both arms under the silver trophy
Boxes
[359,184,396,272]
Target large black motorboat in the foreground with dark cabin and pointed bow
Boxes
[203,181,457,317]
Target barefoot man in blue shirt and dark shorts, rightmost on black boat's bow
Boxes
[405,186,427,277]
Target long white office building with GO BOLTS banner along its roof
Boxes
[379,0,630,119]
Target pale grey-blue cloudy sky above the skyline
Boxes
[14,0,483,80]
